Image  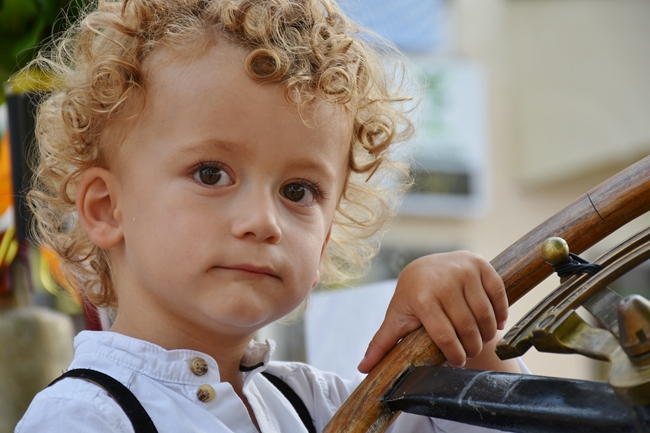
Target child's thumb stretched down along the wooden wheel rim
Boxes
[357,307,422,373]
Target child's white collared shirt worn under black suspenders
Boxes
[15,331,506,433]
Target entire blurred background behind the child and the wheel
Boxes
[0,0,650,432]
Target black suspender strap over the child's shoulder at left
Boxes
[48,368,158,433]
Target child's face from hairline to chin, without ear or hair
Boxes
[110,43,351,335]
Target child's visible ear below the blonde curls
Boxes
[76,167,123,250]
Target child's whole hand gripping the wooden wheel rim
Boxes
[359,251,508,373]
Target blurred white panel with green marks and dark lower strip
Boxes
[401,57,489,217]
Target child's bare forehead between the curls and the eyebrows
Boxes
[117,40,352,176]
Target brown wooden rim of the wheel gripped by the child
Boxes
[323,156,650,433]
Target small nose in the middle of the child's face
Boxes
[231,185,282,244]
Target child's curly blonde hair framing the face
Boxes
[29,0,413,308]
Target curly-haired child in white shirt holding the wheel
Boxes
[16,0,518,433]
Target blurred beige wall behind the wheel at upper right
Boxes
[384,0,650,378]
